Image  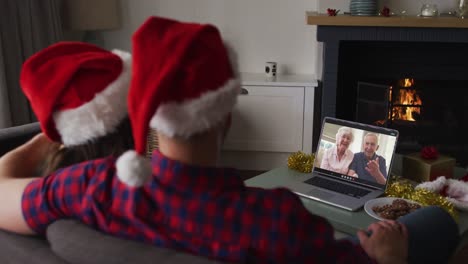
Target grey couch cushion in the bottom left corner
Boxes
[0,230,66,264]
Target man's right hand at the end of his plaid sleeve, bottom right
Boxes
[357,220,408,264]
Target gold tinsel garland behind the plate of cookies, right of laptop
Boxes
[385,177,458,220]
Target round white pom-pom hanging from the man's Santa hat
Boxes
[115,150,152,187]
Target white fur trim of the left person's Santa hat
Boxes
[54,50,132,146]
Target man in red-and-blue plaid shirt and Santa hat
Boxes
[0,17,460,263]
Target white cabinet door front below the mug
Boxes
[224,85,304,152]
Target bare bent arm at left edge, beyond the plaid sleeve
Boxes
[0,134,57,234]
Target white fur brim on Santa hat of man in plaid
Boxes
[150,79,240,138]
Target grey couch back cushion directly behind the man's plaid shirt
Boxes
[47,220,226,264]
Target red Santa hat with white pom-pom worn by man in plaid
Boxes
[116,17,240,186]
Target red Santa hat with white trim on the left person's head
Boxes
[20,42,131,146]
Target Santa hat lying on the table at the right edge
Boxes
[416,174,468,211]
